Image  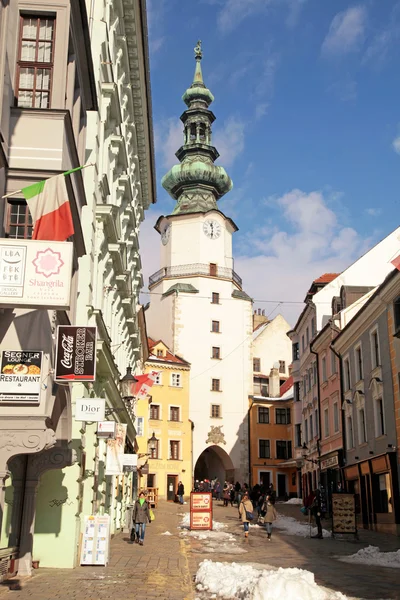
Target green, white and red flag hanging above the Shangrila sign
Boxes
[21,167,83,242]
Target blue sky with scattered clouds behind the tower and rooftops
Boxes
[141,0,400,324]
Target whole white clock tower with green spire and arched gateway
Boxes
[146,42,252,483]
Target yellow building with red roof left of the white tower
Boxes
[136,338,192,500]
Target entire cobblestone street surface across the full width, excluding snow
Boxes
[0,503,400,600]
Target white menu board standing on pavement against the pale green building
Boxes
[81,515,110,565]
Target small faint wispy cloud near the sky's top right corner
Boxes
[321,6,367,56]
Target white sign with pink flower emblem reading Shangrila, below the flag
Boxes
[0,239,73,309]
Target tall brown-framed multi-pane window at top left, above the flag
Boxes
[16,15,55,108]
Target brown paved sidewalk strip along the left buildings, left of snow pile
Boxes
[0,502,194,600]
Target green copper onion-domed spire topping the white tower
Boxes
[161,40,232,214]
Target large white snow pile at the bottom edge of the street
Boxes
[196,560,347,600]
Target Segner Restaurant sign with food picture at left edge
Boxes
[0,350,43,404]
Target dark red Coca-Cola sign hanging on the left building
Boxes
[55,325,96,381]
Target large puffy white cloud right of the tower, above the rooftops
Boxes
[235,189,371,325]
